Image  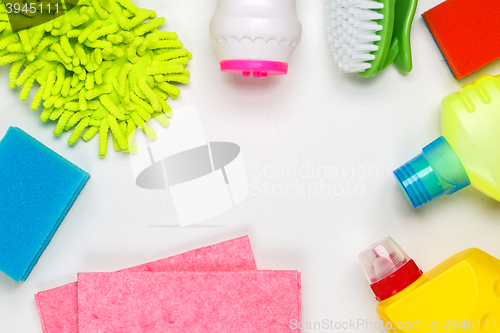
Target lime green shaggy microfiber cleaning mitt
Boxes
[0,0,191,158]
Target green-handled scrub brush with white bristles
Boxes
[327,0,417,77]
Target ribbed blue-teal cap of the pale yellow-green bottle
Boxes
[394,136,470,209]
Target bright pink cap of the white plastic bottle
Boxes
[220,60,288,77]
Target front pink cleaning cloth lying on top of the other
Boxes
[78,271,301,333]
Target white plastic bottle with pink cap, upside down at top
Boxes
[210,0,302,77]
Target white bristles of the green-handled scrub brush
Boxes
[327,0,384,73]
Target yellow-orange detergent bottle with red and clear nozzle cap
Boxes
[360,237,500,333]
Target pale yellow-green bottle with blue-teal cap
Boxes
[394,75,500,209]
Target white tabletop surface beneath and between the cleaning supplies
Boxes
[0,0,500,333]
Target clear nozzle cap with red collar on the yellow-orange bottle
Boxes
[359,237,422,301]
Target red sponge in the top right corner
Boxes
[423,0,500,79]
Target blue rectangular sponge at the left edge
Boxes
[0,127,89,282]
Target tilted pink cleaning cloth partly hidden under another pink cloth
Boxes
[35,236,257,333]
